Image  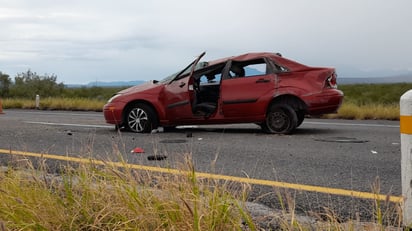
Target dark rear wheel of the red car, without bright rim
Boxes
[262,104,298,134]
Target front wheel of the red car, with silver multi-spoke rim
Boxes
[124,103,158,133]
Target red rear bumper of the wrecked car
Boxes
[305,89,344,115]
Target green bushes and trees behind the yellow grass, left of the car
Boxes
[0,70,123,100]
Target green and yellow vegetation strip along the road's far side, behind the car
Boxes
[0,70,412,120]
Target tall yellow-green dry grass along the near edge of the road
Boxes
[0,156,402,231]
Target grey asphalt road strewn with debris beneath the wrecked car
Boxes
[0,110,401,221]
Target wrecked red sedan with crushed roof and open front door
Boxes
[103,53,343,133]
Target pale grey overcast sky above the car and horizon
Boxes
[0,0,412,84]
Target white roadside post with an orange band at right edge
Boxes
[400,90,412,227]
